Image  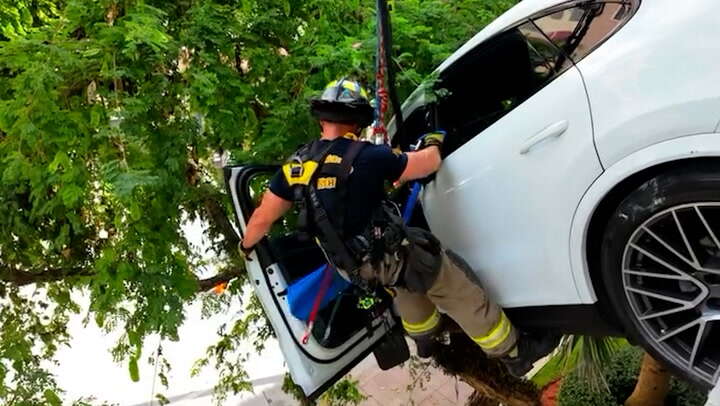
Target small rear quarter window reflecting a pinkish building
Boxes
[533,1,632,63]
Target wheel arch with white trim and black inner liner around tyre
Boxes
[570,133,720,329]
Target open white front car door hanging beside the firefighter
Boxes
[225,165,409,398]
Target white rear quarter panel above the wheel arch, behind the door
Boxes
[577,0,720,167]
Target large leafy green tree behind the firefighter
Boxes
[0,0,515,404]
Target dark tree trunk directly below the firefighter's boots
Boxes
[435,333,539,406]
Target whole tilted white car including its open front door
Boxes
[227,0,720,395]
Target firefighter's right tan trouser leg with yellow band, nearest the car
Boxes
[427,252,518,358]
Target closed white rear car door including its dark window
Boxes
[422,9,602,307]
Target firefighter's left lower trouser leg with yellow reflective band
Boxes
[391,288,441,358]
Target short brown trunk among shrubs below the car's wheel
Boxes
[625,353,670,406]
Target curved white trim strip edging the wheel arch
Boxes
[570,133,720,303]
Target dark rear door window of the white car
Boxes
[438,22,571,155]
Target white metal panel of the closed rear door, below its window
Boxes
[422,68,602,307]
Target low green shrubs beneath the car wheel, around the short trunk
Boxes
[558,345,706,406]
